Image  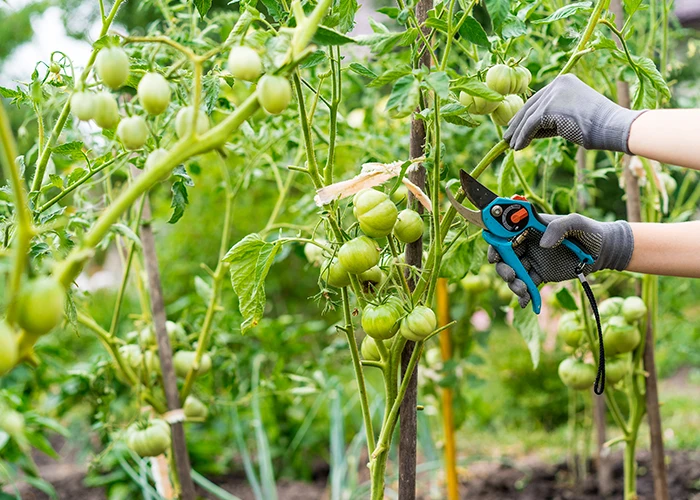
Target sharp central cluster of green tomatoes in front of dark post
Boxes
[305,189,437,361]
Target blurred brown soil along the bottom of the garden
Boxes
[12,452,700,500]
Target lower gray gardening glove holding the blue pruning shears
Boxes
[488,214,634,308]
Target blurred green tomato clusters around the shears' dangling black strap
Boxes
[558,296,647,390]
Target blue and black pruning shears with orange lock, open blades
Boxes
[446,170,595,314]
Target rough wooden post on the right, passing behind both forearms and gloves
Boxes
[610,0,669,500]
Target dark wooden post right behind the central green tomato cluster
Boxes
[399,0,437,500]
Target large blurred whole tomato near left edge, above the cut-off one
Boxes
[17,277,66,336]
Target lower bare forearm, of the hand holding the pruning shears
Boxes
[627,221,700,278]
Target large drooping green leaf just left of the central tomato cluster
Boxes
[223,234,281,334]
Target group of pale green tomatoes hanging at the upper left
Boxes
[71,46,292,156]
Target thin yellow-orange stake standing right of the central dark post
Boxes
[437,278,459,500]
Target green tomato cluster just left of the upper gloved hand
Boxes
[459,63,532,127]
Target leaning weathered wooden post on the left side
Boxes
[141,199,195,500]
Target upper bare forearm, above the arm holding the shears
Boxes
[628,109,700,170]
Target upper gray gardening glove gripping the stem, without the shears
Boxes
[503,75,644,154]
